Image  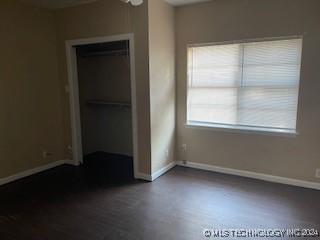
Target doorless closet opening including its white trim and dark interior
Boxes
[67,35,137,179]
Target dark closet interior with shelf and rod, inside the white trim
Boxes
[76,41,133,178]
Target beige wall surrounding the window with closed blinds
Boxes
[176,0,320,182]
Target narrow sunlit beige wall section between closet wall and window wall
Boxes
[149,0,175,173]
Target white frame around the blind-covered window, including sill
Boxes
[184,35,303,137]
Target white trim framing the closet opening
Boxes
[66,33,139,177]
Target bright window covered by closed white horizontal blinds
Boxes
[187,38,302,133]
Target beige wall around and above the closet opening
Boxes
[55,0,151,174]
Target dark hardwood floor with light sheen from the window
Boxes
[0,158,320,240]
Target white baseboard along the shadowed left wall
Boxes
[0,160,69,186]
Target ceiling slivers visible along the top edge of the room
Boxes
[20,0,210,9]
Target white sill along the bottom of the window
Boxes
[185,122,299,138]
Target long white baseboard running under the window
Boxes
[177,161,320,190]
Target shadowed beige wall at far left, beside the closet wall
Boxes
[0,0,63,178]
